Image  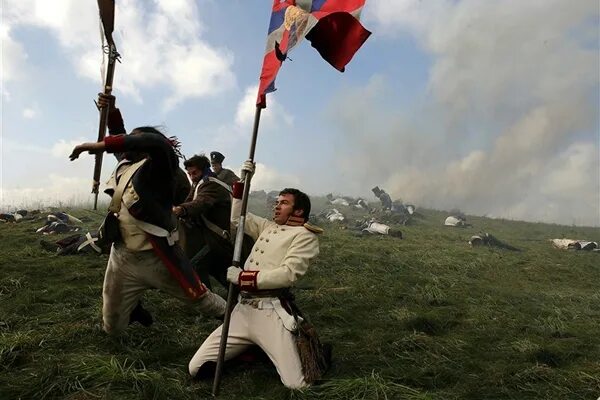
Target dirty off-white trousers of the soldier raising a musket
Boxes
[102,245,226,334]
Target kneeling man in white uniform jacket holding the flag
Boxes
[189,161,320,389]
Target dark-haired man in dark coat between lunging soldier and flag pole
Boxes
[173,154,233,289]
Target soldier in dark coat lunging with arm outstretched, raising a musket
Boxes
[69,95,225,334]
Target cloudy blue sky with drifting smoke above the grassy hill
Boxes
[0,0,600,226]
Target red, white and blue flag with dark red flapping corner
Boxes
[256,0,371,108]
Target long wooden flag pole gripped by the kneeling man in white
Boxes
[212,105,263,397]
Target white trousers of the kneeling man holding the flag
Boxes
[189,303,308,389]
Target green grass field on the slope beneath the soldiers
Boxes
[0,199,600,400]
